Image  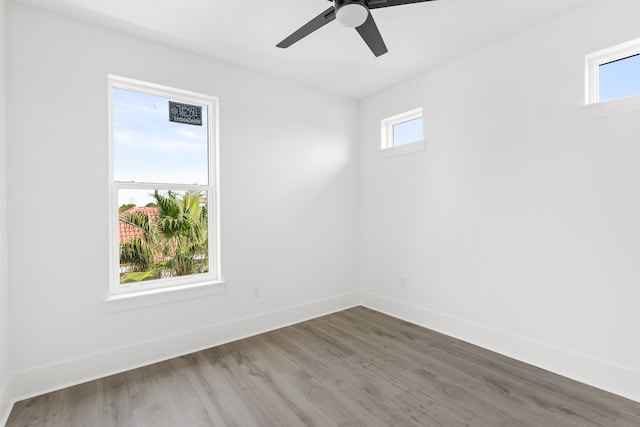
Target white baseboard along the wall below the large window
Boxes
[13,292,360,401]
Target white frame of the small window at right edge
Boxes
[585,38,640,105]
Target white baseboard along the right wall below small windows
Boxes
[361,291,640,402]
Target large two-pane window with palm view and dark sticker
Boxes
[109,76,220,294]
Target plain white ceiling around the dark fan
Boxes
[13,0,602,99]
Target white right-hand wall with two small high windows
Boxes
[360,0,640,401]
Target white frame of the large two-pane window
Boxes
[107,74,223,305]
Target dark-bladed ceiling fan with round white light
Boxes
[276,0,433,56]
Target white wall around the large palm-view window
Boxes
[7,4,358,397]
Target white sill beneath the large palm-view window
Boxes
[104,281,226,312]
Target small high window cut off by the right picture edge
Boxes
[586,39,640,104]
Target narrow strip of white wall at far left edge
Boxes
[0,0,12,424]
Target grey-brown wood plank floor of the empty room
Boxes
[7,307,640,427]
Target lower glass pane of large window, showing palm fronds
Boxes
[118,189,209,283]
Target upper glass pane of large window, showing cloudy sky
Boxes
[113,88,208,185]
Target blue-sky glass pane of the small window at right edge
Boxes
[599,54,640,101]
